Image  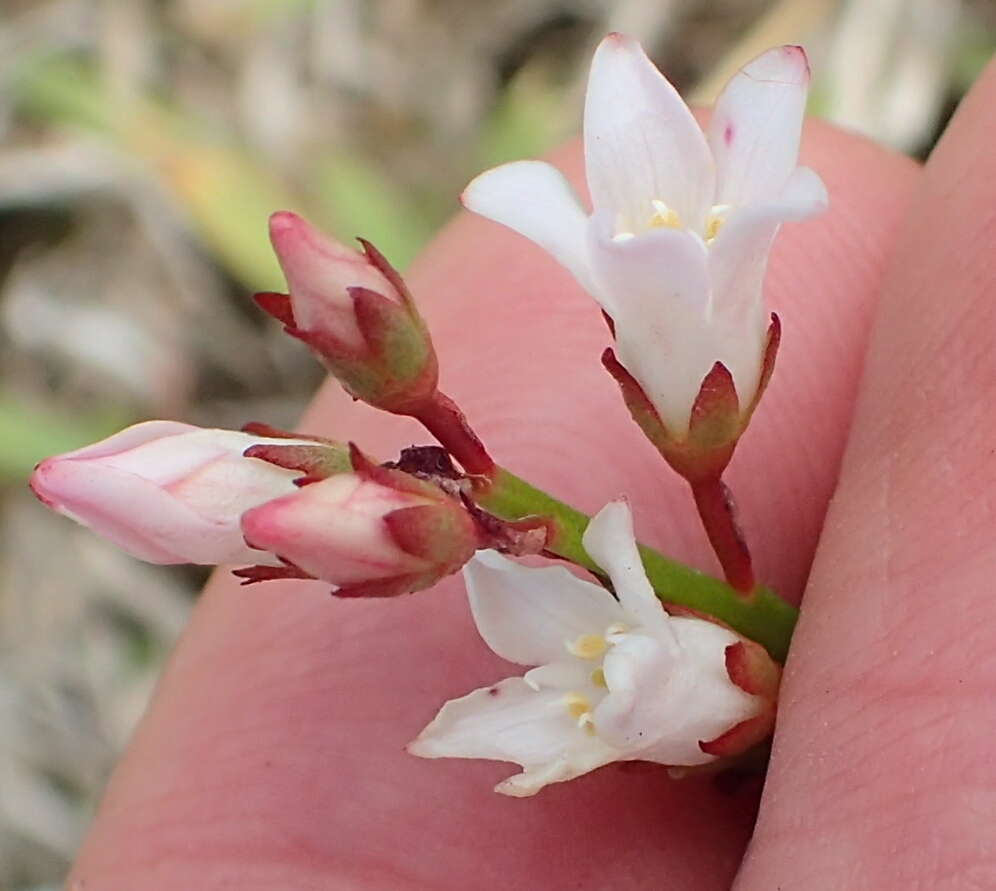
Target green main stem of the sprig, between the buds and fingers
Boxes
[475,468,798,662]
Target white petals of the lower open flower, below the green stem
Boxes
[409,501,765,796]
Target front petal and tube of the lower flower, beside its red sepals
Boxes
[594,616,763,765]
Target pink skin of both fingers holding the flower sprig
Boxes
[71,59,996,891]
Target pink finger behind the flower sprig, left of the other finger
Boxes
[64,125,916,891]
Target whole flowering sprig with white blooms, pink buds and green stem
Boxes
[31,34,827,797]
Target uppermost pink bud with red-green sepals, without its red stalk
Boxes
[256,211,438,413]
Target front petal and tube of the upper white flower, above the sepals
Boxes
[589,216,722,437]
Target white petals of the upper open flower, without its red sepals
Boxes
[462,34,827,438]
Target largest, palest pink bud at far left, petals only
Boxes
[31,421,320,564]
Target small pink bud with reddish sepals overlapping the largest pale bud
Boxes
[242,461,478,596]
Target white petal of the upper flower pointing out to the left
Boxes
[460,161,591,291]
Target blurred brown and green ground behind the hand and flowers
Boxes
[0,0,996,889]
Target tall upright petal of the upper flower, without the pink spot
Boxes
[584,34,715,232]
